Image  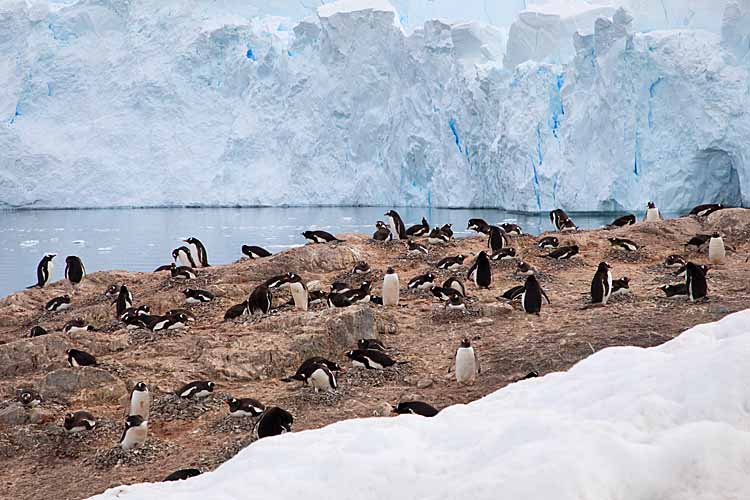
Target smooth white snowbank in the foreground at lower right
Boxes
[93,311,750,500]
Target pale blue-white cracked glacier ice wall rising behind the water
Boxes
[0,0,750,211]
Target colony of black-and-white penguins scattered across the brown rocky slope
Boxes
[5,203,748,490]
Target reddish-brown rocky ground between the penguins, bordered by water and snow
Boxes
[0,209,750,500]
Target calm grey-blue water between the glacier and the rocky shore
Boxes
[0,207,628,297]
